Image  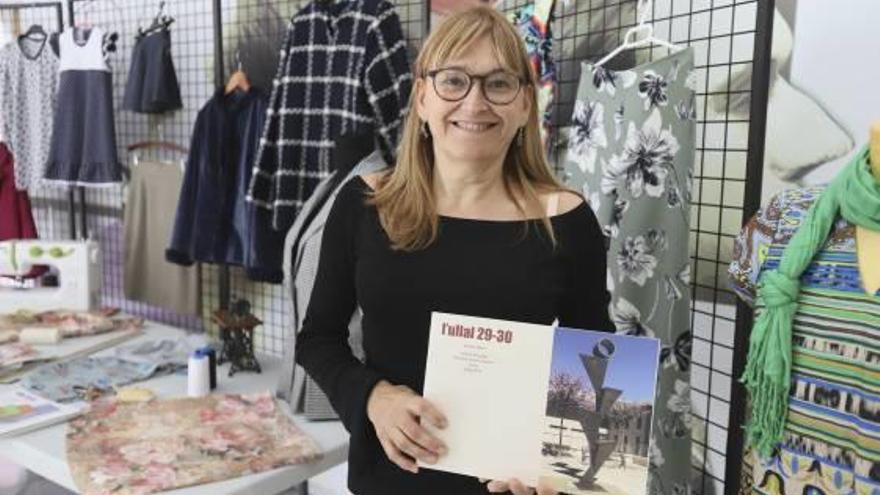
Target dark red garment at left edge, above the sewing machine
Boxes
[0,143,37,241]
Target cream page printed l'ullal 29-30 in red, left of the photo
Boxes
[420,312,553,486]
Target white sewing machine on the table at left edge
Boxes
[0,239,101,313]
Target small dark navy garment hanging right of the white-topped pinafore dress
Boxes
[122,29,183,113]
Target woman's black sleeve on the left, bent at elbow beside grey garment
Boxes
[296,179,381,435]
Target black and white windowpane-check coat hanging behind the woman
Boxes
[248,0,412,232]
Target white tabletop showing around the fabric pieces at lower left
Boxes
[0,322,348,495]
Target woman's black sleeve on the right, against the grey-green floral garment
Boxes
[559,204,614,332]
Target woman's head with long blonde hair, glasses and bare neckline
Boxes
[373,7,560,250]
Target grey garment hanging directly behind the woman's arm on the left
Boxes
[278,151,387,419]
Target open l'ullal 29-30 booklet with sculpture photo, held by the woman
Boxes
[420,312,660,495]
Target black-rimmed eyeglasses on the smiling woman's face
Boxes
[427,68,525,105]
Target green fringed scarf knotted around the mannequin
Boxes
[742,148,880,457]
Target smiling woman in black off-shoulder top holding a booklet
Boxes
[295,7,612,495]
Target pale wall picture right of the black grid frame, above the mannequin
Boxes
[762,0,880,203]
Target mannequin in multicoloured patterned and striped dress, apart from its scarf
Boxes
[729,126,880,495]
